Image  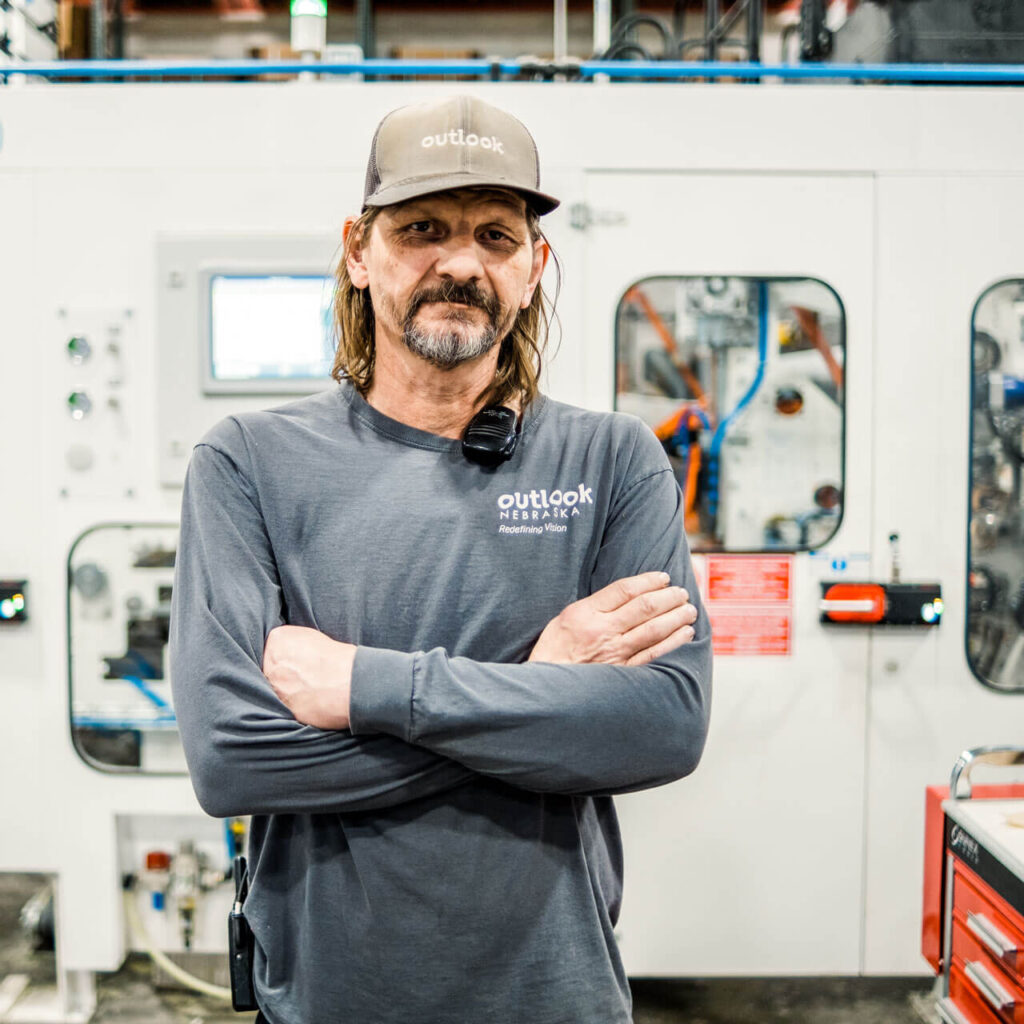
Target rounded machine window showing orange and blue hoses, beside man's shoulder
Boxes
[615,276,845,551]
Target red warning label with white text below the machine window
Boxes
[694,555,793,656]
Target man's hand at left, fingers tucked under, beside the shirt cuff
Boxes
[263,626,355,729]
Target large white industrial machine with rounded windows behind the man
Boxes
[0,81,1024,1021]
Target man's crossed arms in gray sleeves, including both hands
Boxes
[171,445,711,816]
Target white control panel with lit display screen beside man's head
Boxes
[157,233,340,485]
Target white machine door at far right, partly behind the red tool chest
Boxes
[864,174,1024,974]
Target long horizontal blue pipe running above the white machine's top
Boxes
[6,59,1024,84]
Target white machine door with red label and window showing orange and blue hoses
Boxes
[581,171,874,976]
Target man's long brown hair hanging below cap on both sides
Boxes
[331,207,561,409]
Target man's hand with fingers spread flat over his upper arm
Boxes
[529,572,697,665]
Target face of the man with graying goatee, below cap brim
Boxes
[349,189,546,369]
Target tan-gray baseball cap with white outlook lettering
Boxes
[362,96,558,213]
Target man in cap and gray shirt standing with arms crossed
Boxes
[171,96,711,1024]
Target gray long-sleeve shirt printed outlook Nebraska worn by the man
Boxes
[171,383,711,1024]
